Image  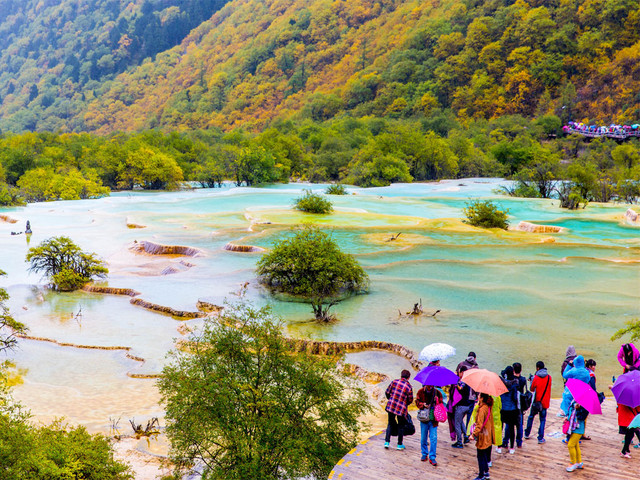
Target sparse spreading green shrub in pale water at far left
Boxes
[26,237,109,291]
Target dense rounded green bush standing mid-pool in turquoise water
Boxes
[257,227,369,321]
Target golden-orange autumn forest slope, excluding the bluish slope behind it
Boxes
[79,0,640,133]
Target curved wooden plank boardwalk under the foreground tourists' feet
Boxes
[329,397,640,480]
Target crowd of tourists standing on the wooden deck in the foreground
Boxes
[384,343,640,480]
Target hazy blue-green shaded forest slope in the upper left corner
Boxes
[0,0,226,131]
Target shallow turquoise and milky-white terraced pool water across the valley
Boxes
[0,179,640,431]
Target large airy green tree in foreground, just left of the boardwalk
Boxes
[158,304,369,480]
